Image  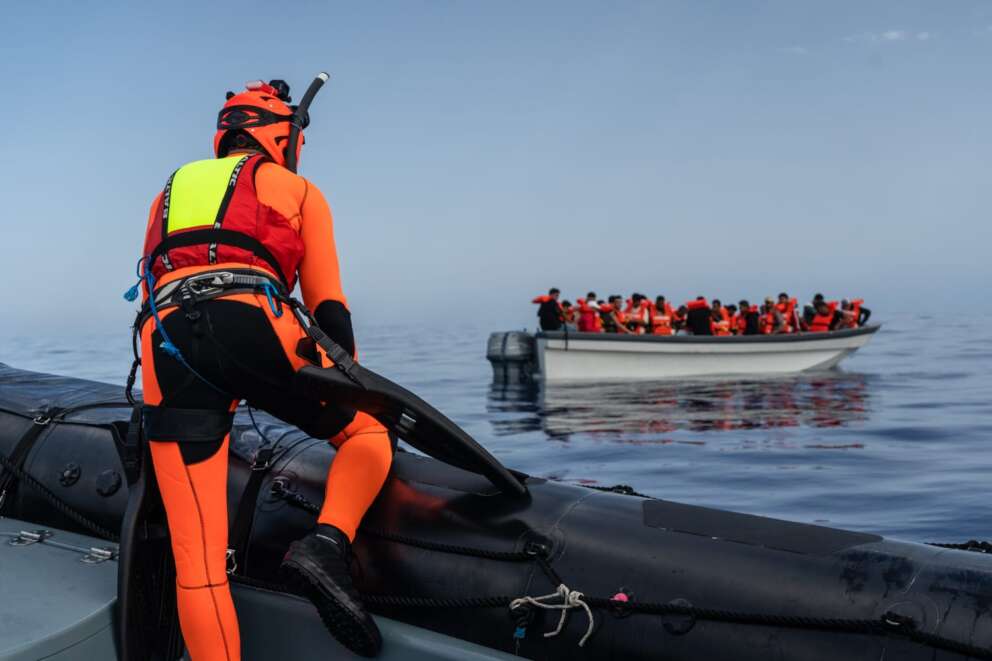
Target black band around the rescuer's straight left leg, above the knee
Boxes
[143,405,234,465]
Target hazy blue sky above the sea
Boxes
[0,0,992,334]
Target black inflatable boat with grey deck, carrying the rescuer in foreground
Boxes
[0,365,992,661]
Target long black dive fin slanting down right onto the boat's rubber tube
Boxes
[297,361,527,496]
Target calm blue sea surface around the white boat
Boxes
[0,314,992,541]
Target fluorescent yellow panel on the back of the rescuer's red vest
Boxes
[167,156,242,233]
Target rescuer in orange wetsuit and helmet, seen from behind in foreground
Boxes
[135,74,394,661]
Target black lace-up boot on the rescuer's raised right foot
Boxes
[280,524,382,657]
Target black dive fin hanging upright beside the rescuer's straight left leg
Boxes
[116,421,183,661]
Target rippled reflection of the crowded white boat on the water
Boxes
[487,372,871,443]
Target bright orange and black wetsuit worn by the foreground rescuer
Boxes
[141,156,393,661]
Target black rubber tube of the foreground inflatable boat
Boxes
[0,366,992,661]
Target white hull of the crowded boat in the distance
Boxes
[537,326,879,382]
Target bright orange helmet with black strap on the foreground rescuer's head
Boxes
[214,80,308,166]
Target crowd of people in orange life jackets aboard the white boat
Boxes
[533,288,871,335]
